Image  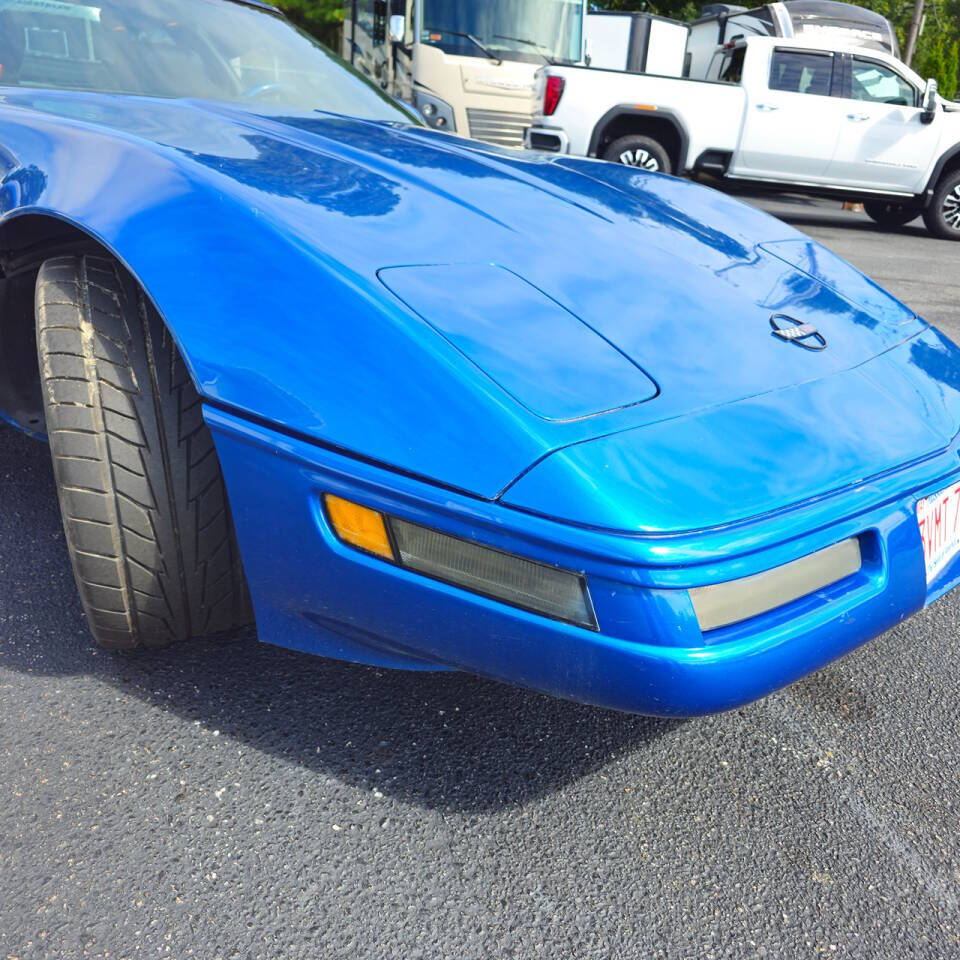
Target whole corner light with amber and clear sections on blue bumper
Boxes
[323,494,598,630]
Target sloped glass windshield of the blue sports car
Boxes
[0,0,413,122]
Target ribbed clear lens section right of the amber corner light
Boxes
[390,517,597,630]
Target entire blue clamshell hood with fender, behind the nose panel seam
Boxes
[5,91,936,506]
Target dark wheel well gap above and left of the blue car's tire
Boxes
[0,214,113,433]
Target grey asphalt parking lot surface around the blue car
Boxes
[0,201,960,960]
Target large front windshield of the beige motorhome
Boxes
[420,0,583,63]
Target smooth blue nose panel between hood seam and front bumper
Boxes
[504,329,960,535]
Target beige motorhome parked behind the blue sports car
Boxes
[343,0,587,147]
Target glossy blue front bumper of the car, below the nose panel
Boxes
[205,408,960,716]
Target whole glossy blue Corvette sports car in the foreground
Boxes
[0,0,960,716]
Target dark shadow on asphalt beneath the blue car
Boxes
[0,426,679,812]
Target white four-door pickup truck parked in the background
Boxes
[525,37,960,240]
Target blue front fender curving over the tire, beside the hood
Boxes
[0,106,544,498]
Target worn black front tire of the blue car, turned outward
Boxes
[36,256,252,650]
